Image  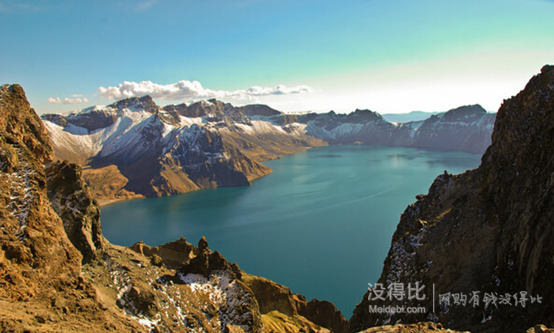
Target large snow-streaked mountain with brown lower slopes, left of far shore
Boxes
[43,96,322,199]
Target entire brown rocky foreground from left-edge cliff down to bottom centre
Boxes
[0,85,347,332]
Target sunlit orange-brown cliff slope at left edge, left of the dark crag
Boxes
[0,85,141,332]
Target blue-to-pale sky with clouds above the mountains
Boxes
[0,0,554,114]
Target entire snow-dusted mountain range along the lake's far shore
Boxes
[42,96,494,199]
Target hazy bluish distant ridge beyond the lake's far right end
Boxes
[232,105,496,154]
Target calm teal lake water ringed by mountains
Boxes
[102,146,480,318]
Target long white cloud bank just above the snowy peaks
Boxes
[98,80,312,100]
